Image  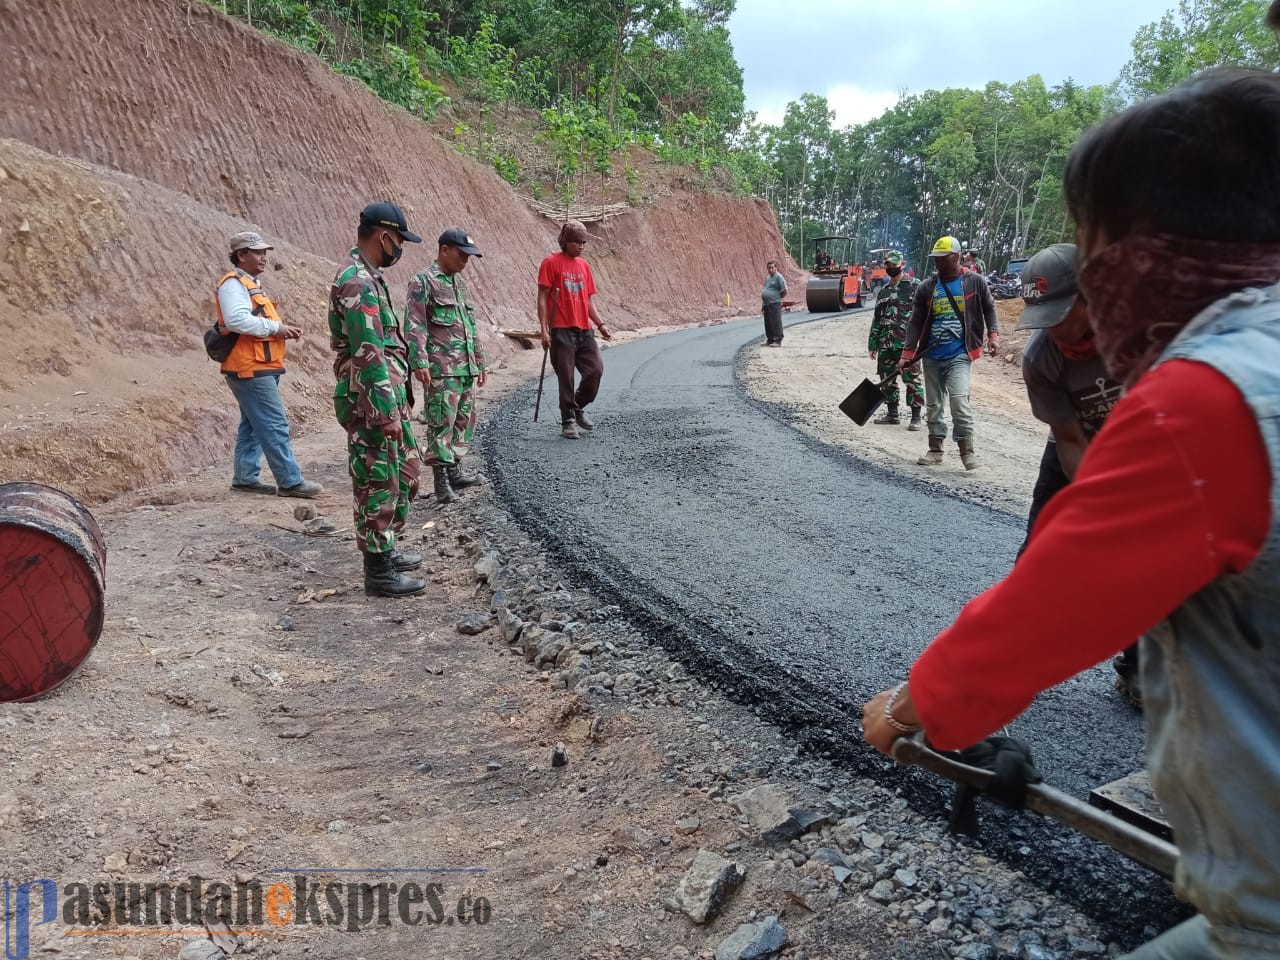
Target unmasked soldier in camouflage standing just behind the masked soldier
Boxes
[404,227,485,503]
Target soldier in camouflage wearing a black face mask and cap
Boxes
[329,204,426,596]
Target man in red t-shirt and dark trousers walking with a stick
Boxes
[538,220,613,440]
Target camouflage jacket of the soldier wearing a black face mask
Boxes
[329,250,408,429]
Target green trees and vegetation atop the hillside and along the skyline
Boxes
[206,0,1280,266]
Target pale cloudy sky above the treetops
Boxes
[728,0,1178,127]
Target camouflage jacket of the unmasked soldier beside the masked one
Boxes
[404,264,485,380]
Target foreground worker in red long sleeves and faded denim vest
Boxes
[863,70,1280,960]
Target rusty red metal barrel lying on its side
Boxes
[0,483,106,703]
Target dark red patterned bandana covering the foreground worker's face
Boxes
[1078,233,1280,388]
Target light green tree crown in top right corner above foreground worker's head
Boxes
[1121,0,1280,100]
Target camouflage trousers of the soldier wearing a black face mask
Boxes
[347,411,422,553]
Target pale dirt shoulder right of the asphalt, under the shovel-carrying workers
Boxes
[741,311,1048,516]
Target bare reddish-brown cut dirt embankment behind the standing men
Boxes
[0,0,782,502]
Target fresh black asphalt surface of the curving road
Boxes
[484,314,1167,942]
